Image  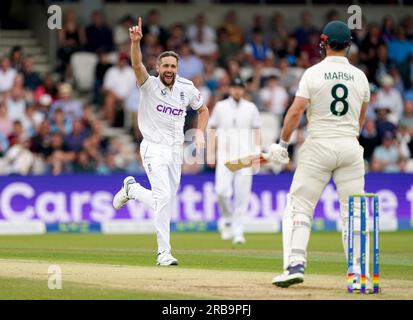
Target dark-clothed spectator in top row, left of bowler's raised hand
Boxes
[86,10,114,52]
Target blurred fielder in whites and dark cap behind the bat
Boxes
[208,78,261,244]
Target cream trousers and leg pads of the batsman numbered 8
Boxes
[283,137,368,272]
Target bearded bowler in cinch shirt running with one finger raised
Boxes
[113,18,209,266]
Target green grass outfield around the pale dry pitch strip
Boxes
[0,231,413,299]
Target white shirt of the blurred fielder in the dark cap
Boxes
[208,97,261,161]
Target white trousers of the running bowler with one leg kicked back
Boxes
[129,140,183,253]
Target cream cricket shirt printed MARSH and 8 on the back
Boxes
[296,57,370,138]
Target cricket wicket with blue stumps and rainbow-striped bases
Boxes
[347,193,379,293]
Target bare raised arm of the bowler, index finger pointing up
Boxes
[129,17,149,85]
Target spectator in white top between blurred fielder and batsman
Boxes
[260,75,289,123]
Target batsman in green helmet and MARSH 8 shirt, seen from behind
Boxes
[269,21,370,287]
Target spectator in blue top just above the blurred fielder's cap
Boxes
[244,28,274,67]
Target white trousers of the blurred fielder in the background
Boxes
[215,160,253,237]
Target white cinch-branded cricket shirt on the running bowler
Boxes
[138,75,204,146]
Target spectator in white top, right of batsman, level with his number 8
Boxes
[377,74,403,124]
